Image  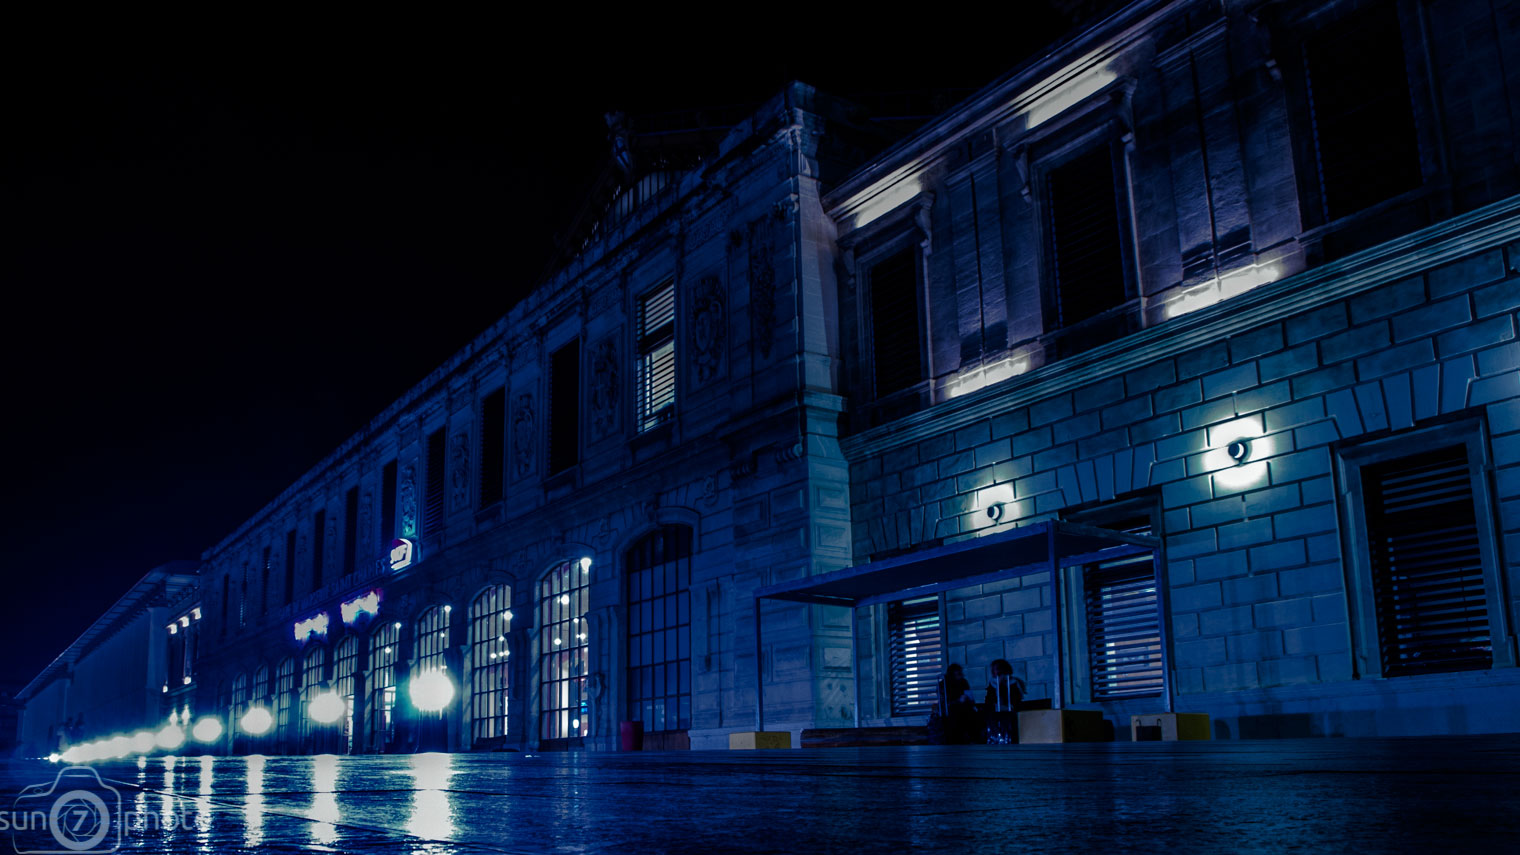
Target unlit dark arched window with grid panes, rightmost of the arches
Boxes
[626,525,692,733]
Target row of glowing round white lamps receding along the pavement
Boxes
[47,669,454,764]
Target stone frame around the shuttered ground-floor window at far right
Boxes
[1335,417,1515,680]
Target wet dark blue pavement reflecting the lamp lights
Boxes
[0,736,1520,855]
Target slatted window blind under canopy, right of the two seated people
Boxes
[1082,522,1163,700]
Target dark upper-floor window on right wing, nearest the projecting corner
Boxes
[866,246,926,397]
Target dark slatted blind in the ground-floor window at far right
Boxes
[1362,446,1493,677]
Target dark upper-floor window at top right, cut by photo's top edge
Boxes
[1303,3,1421,222]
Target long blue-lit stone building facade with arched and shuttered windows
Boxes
[47,0,1520,753]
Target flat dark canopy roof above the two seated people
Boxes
[755,520,1160,607]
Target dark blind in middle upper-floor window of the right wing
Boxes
[1046,143,1125,327]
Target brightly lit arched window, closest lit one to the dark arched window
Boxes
[538,561,591,739]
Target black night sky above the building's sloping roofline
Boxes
[0,15,1082,691]
